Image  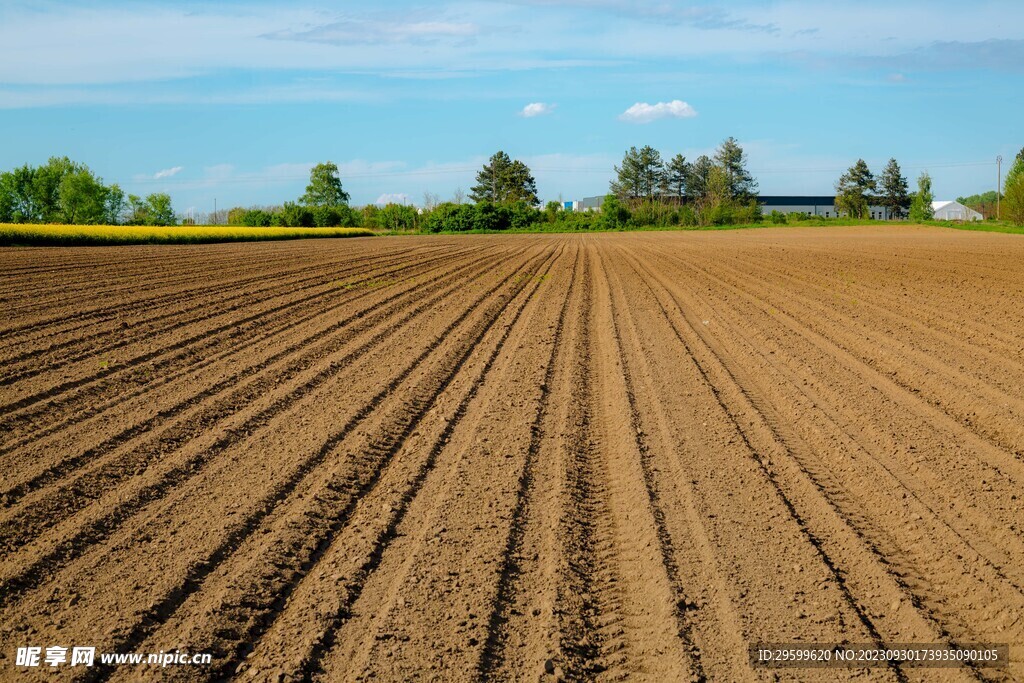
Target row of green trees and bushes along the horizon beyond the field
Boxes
[0,146,1024,232]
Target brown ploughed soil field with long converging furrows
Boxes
[0,227,1024,681]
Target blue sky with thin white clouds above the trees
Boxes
[0,0,1024,212]
